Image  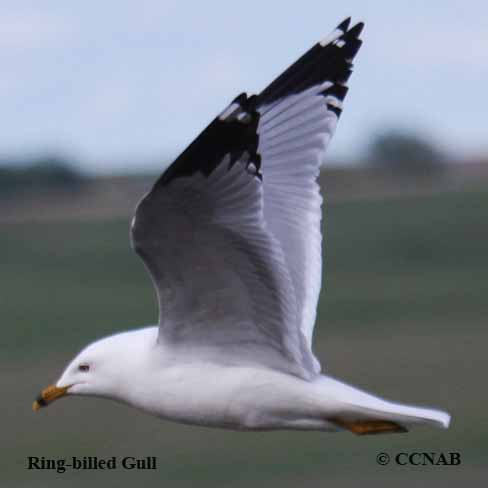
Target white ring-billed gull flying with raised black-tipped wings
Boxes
[33,18,450,435]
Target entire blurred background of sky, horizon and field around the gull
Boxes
[0,0,488,487]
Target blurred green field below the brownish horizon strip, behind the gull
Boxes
[0,191,488,488]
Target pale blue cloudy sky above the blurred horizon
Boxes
[0,0,488,172]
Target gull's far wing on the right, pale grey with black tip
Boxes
[258,19,363,347]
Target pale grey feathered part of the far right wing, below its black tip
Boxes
[258,82,337,354]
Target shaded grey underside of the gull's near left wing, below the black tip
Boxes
[132,158,313,377]
